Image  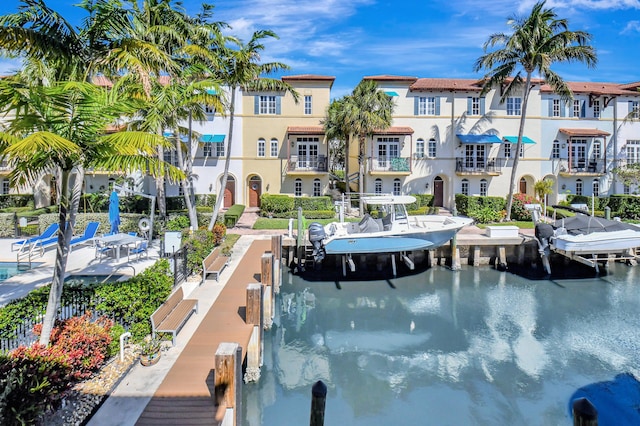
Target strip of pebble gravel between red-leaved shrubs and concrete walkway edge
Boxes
[38,347,138,426]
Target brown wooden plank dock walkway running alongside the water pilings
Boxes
[136,240,271,426]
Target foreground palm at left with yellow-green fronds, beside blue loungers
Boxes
[0,77,183,345]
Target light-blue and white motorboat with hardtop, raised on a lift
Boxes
[309,195,473,269]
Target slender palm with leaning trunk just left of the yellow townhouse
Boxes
[209,30,299,231]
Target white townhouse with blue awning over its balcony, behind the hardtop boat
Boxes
[358,76,540,208]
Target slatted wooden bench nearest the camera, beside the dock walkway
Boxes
[151,287,198,346]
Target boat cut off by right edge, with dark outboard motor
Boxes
[532,206,640,273]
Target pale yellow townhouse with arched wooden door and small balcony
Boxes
[242,75,334,207]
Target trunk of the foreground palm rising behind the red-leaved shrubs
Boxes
[39,168,84,346]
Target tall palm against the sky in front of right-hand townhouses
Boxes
[474,1,597,220]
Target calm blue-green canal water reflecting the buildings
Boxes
[244,265,640,426]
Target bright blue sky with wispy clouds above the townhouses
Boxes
[0,0,640,97]
